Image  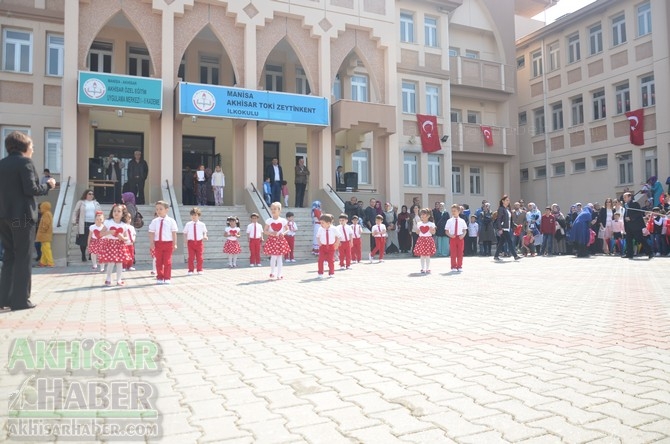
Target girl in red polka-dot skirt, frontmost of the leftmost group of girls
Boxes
[98,204,128,286]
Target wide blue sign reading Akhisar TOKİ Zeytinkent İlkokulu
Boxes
[179,82,330,126]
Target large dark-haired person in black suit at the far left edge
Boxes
[0,131,56,310]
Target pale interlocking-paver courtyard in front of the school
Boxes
[0,253,670,444]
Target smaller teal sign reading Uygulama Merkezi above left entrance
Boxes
[77,71,163,111]
